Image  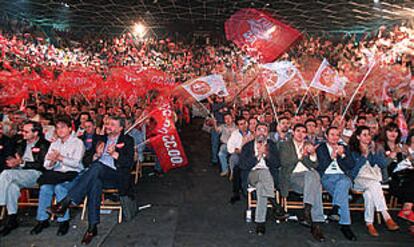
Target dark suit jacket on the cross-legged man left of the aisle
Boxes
[103,134,134,196]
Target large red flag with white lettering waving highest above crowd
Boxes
[224,8,301,62]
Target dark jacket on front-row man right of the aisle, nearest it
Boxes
[238,139,280,193]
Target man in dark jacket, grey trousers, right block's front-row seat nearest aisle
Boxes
[239,123,288,235]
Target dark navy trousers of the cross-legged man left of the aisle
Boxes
[68,161,120,225]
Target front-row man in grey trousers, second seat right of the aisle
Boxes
[279,124,325,242]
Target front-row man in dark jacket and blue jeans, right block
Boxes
[316,127,356,241]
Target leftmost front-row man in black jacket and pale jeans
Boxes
[0,121,50,236]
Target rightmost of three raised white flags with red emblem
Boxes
[310,58,348,95]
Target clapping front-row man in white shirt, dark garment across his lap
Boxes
[30,116,85,236]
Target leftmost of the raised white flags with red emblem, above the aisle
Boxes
[182,75,228,101]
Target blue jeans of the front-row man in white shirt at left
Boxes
[36,179,76,222]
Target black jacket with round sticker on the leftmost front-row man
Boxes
[16,137,50,171]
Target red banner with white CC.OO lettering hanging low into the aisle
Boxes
[150,103,188,172]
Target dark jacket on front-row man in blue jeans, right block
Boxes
[316,143,353,177]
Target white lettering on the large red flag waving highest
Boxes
[243,17,276,44]
